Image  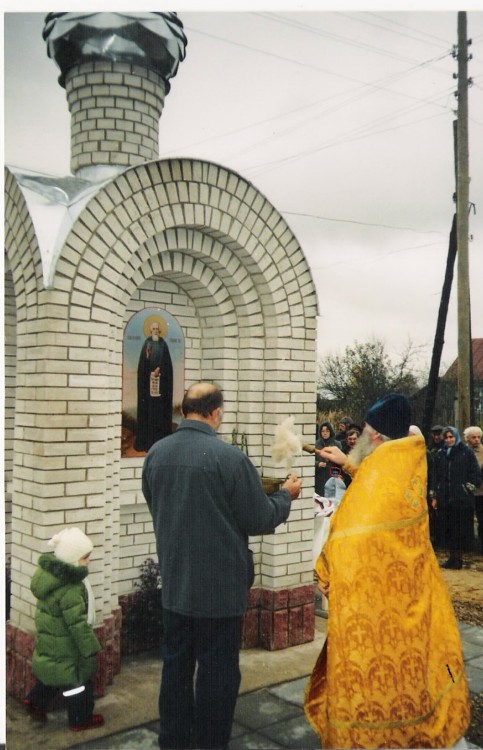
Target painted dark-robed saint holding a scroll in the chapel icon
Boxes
[134,321,173,451]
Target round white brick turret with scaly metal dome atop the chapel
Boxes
[43,13,187,177]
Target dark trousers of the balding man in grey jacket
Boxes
[159,610,241,750]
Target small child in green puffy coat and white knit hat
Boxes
[24,528,104,732]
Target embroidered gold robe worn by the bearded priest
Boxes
[305,436,470,748]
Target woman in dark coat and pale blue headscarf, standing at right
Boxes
[431,427,481,570]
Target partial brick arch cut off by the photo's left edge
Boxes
[4,167,42,325]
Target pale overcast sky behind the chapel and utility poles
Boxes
[4,7,483,376]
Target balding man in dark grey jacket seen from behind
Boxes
[142,383,301,748]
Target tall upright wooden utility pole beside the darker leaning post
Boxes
[456,11,471,431]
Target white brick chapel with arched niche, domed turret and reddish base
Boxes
[5,13,317,697]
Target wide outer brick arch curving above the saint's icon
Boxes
[58,160,316,335]
